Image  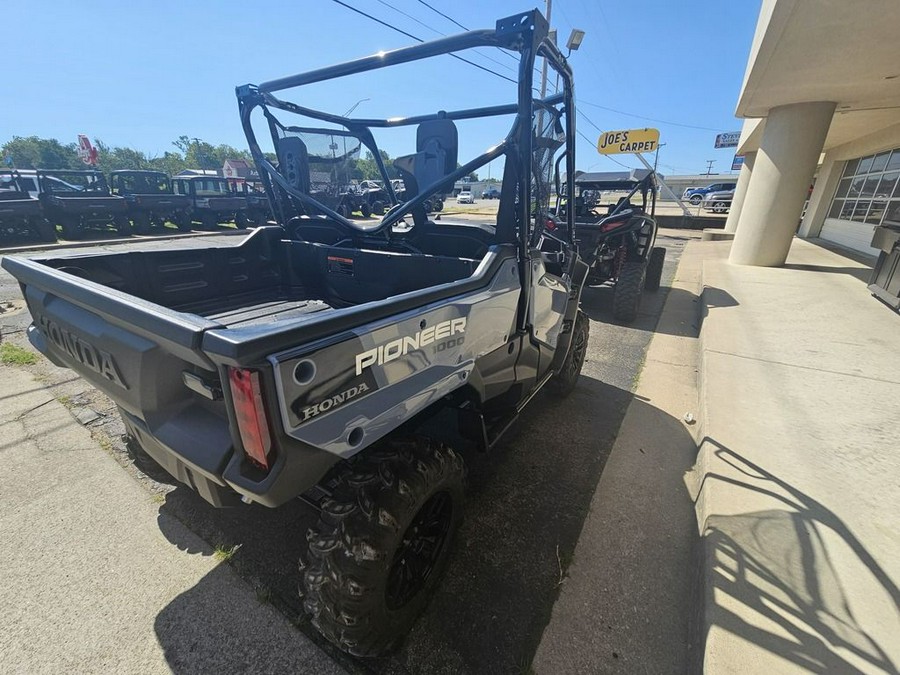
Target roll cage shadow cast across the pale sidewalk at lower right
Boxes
[701,438,900,673]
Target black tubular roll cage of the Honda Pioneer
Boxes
[236,10,575,260]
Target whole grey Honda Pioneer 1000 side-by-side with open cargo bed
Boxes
[3,10,588,656]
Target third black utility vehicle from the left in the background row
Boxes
[109,171,191,234]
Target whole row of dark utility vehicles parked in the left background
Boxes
[0,169,269,242]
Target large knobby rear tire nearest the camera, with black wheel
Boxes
[300,438,465,656]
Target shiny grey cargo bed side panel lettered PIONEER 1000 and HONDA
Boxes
[270,258,521,457]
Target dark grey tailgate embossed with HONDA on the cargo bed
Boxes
[3,257,220,416]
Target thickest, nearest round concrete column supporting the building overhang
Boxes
[729,102,836,267]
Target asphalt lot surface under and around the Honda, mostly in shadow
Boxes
[0,231,690,674]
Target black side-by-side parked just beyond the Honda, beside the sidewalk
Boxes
[558,169,666,321]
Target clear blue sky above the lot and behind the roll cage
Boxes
[0,0,760,175]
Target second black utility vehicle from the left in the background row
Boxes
[37,169,131,239]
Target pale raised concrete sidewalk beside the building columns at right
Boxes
[692,240,900,673]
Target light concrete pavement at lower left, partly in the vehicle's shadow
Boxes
[0,366,343,673]
